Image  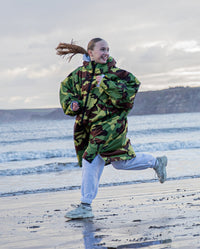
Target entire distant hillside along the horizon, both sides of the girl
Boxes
[0,87,200,122]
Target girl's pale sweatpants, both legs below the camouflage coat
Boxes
[81,153,156,204]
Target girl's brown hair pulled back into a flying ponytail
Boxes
[56,38,103,62]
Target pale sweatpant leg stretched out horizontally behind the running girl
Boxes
[112,153,156,170]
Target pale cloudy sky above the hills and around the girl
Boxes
[0,0,200,109]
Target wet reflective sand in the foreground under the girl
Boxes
[0,178,200,249]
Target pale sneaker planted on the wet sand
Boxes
[65,203,94,219]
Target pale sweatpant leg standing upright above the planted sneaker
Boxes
[81,155,105,204]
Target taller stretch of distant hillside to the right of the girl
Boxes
[130,87,200,115]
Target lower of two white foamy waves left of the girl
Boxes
[0,162,78,176]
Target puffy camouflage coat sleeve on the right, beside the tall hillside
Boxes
[100,70,140,110]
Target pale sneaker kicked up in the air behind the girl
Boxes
[154,156,167,183]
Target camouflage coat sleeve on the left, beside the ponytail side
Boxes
[60,72,82,116]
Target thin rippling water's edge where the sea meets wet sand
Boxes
[0,175,200,197]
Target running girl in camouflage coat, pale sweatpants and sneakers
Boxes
[56,38,167,219]
